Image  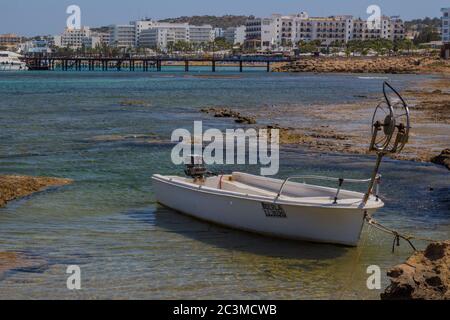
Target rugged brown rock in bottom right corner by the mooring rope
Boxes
[381,241,450,300]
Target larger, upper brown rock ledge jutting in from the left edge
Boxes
[0,176,73,208]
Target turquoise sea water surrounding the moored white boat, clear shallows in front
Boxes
[0,68,450,299]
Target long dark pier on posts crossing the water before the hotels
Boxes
[25,56,294,72]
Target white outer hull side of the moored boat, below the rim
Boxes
[153,178,376,246]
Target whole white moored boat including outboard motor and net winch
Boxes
[152,83,410,246]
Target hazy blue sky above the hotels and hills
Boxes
[0,0,450,35]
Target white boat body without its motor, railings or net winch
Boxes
[153,172,384,246]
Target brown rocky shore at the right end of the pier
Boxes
[273,57,442,74]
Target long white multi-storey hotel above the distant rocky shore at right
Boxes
[246,12,405,50]
